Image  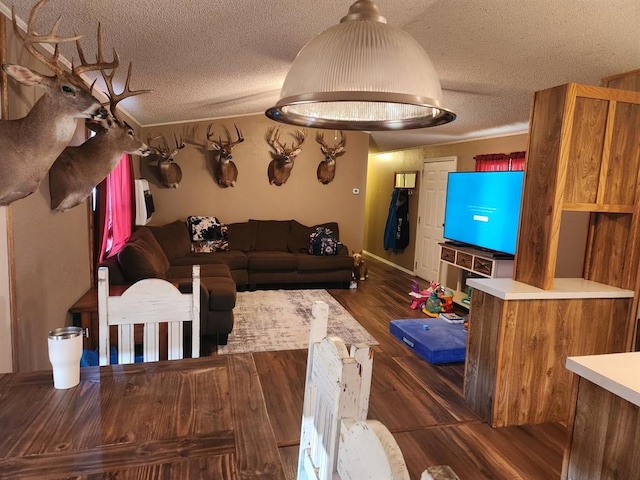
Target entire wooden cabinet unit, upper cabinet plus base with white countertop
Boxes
[464,83,640,426]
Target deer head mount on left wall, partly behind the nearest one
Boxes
[49,56,150,212]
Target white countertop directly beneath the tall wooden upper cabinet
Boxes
[467,278,633,300]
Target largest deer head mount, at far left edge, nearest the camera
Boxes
[0,0,118,205]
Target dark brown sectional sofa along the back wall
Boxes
[100,220,353,345]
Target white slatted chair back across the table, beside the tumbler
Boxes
[98,265,200,365]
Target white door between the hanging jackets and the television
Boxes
[415,157,458,284]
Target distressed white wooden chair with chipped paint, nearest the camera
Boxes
[297,302,409,480]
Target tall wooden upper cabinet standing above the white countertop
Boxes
[514,83,640,289]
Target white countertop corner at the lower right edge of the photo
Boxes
[566,352,640,407]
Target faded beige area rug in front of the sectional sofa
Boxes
[218,290,378,354]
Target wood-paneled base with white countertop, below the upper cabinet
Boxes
[464,278,634,427]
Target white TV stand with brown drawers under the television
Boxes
[439,242,513,308]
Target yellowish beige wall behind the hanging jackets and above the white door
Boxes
[364,133,527,272]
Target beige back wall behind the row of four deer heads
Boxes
[135,118,369,250]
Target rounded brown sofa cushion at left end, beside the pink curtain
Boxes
[118,228,169,282]
